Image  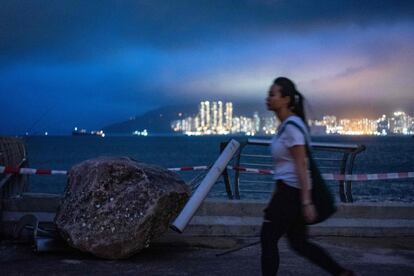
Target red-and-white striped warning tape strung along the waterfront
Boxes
[0,166,414,181]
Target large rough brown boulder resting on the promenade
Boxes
[55,158,189,259]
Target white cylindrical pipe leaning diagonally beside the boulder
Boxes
[171,139,240,233]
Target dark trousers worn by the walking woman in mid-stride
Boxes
[261,181,344,276]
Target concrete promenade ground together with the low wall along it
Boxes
[0,195,414,276]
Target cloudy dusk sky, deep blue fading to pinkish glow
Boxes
[0,0,414,134]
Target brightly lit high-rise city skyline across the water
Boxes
[171,101,414,136]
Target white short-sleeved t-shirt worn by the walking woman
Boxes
[271,115,310,189]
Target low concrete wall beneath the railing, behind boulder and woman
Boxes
[0,194,414,239]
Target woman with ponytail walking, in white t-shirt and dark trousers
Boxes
[261,77,355,276]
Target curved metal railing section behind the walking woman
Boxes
[220,139,365,202]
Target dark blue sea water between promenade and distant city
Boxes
[24,136,414,202]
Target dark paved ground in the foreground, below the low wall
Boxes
[0,237,414,276]
